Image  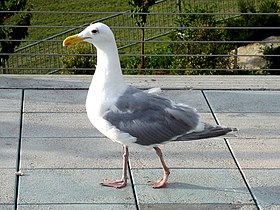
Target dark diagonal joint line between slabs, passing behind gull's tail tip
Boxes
[201,90,262,210]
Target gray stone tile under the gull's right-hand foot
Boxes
[133,169,254,205]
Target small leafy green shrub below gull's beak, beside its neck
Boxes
[61,43,96,74]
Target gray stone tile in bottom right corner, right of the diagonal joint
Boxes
[244,168,280,209]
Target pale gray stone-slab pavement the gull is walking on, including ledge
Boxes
[0,75,280,210]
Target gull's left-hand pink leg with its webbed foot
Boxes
[100,146,128,188]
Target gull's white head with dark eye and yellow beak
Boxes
[63,23,115,47]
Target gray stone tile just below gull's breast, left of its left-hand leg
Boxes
[21,138,122,169]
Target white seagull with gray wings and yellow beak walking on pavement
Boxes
[63,23,236,188]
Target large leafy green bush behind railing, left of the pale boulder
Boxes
[171,5,233,74]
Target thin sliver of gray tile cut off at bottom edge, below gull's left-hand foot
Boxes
[17,204,136,210]
